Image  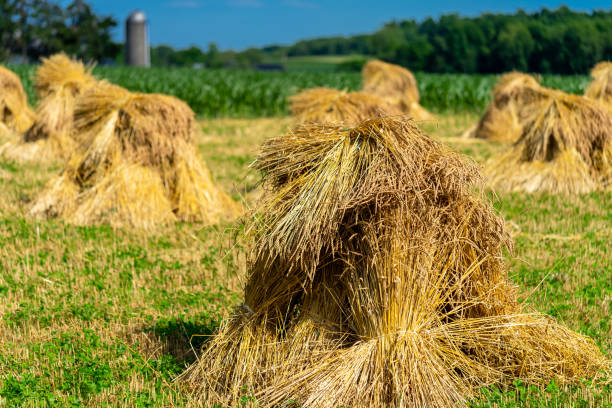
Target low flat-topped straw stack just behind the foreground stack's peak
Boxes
[289,88,402,126]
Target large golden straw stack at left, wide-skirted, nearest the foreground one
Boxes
[30,83,239,229]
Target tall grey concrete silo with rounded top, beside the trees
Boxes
[125,10,151,67]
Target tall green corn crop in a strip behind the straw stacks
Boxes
[7,64,589,118]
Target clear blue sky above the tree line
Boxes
[90,0,612,50]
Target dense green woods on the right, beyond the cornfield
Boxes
[286,6,612,74]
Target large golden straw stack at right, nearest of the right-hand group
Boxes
[486,91,612,194]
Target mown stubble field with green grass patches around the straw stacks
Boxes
[0,115,612,408]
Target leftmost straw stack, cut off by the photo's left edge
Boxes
[0,66,34,135]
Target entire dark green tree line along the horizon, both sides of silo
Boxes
[0,0,612,74]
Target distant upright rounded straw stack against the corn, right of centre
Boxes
[361,60,434,121]
